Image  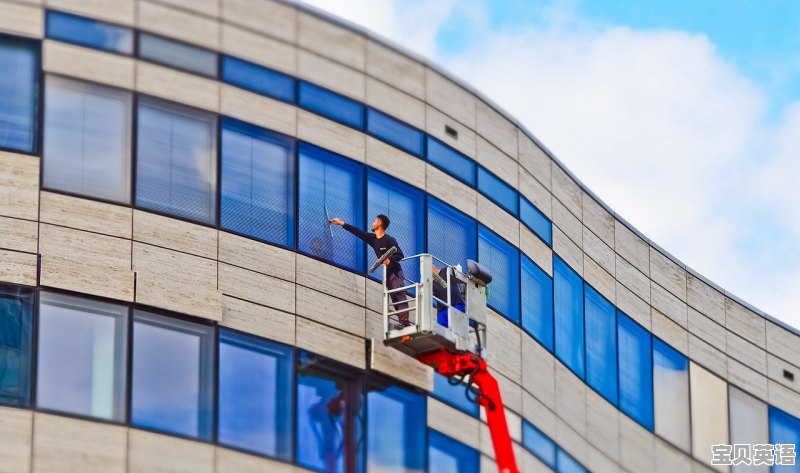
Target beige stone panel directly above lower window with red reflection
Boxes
[297,317,366,369]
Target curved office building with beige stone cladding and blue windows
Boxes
[0,0,800,473]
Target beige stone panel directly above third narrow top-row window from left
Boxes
[222,23,297,74]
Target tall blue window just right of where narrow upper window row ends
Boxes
[553,254,585,379]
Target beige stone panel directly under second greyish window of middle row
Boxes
[133,210,219,259]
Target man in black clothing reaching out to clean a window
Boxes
[331,214,410,326]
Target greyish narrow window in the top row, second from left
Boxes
[139,33,219,77]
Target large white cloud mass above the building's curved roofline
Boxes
[296,0,800,326]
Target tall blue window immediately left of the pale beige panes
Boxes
[617,312,653,431]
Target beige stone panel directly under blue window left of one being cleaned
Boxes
[219,231,296,281]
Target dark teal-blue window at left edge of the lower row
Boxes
[0,283,33,407]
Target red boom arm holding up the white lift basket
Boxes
[418,349,519,473]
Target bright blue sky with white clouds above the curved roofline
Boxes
[302,0,800,327]
